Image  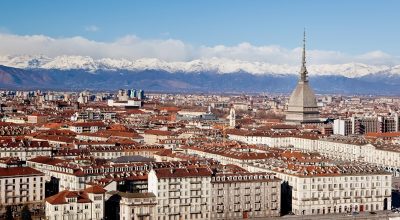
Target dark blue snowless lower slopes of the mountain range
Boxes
[0,63,400,95]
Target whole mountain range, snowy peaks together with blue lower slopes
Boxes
[0,56,400,95]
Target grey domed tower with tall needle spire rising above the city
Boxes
[286,31,320,124]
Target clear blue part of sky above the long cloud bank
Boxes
[0,0,400,64]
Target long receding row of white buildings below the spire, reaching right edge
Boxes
[228,132,400,176]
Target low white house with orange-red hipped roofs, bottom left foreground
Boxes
[46,186,106,220]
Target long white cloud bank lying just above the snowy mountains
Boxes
[0,33,400,66]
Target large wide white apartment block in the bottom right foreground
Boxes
[248,162,392,215]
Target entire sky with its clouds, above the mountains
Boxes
[0,0,400,65]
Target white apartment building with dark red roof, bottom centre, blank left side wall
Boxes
[148,167,212,220]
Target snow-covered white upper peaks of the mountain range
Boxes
[0,55,400,78]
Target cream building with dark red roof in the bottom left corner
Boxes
[0,167,45,214]
